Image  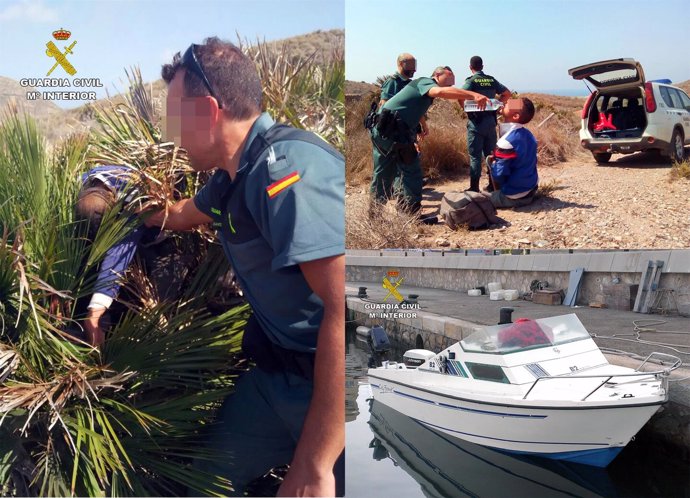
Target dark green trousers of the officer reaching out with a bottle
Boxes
[369,128,423,211]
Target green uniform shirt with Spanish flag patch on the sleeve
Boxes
[194,113,345,352]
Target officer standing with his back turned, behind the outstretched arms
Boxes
[462,55,511,192]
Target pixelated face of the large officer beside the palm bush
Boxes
[164,69,221,171]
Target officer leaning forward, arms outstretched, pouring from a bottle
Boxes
[370,66,488,213]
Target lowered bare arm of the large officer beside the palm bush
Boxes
[278,255,345,496]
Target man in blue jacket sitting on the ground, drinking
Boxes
[487,98,539,208]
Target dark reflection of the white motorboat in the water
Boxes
[369,401,615,498]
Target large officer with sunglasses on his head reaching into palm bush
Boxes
[147,38,345,496]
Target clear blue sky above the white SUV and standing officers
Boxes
[345,0,690,92]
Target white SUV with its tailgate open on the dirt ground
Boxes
[568,59,690,164]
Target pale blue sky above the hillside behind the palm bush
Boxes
[0,0,345,107]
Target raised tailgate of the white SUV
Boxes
[568,59,645,90]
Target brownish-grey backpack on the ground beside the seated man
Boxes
[441,191,501,230]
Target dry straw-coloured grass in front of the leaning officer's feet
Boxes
[345,191,425,249]
